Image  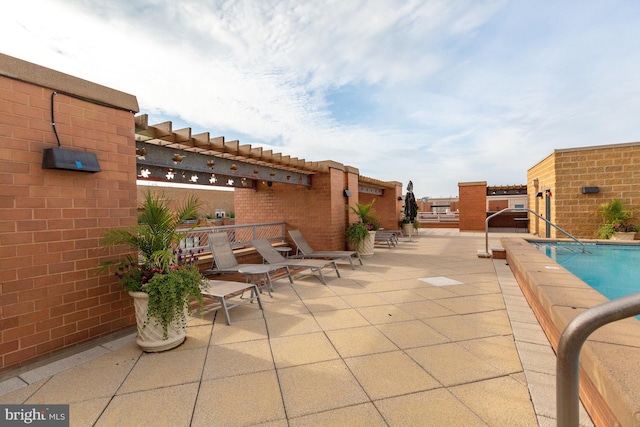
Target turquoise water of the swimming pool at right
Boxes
[530,242,640,300]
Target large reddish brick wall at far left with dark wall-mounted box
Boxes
[0,55,137,372]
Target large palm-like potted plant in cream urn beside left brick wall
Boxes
[99,191,204,352]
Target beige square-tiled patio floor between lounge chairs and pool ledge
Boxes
[0,229,592,427]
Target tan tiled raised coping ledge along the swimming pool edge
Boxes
[501,237,640,426]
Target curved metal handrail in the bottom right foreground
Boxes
[556,292,640,427]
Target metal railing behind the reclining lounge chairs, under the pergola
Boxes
[180,222,285,252]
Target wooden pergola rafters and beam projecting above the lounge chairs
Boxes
[135,114,393,194]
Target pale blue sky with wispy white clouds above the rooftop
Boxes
[0,0,640,198]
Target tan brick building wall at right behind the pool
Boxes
[527,143,640,239]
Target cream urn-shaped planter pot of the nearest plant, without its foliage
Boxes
[129,292,187,353]
